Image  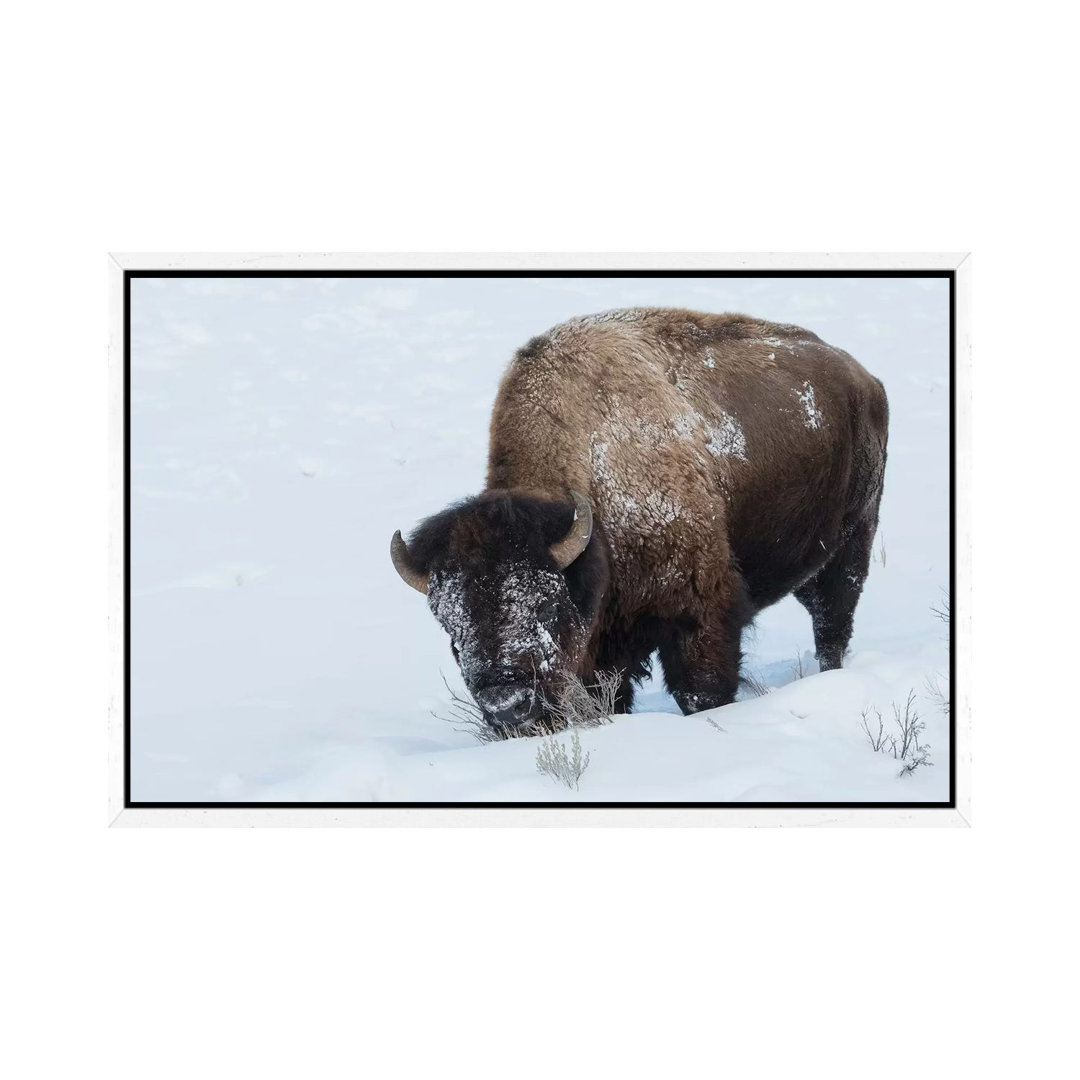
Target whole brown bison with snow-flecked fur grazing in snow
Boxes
[391,308,889,733]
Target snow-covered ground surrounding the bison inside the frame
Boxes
[131,279,949,801]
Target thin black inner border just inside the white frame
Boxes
[123,268,957,810]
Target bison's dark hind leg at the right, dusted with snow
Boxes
[795,522,875,672]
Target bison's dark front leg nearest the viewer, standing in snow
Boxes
[660,621,742,714]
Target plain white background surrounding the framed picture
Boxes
[0,2,1077,1078]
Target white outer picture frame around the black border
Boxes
[108,253,971,827]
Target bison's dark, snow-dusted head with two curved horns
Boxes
[390,491,607,728]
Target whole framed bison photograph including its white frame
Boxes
[110,255,970,825]
